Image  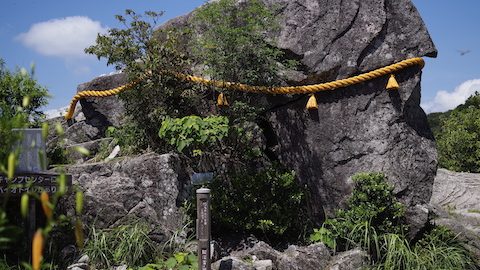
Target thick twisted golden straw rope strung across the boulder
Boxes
[65,57,425,120]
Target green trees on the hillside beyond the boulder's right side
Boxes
[429,92,480,173]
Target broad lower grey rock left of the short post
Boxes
[61,153,190,240]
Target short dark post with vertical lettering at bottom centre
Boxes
[197,188,211,270]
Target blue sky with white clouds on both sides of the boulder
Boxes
[0,0,480,112]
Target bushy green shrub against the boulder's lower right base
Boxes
[310,173,406,254]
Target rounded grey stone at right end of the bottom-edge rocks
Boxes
[327,248,368,270]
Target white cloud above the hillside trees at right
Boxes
[422,79,480,113]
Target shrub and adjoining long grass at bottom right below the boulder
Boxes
[310,173,476,270]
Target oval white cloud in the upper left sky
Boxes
[16,16,107,59]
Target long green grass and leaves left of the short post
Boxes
[83,204,197,270]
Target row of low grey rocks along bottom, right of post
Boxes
[212,242,368,270]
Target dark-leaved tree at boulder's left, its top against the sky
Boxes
[85,10,202,148]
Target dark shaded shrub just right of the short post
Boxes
[210,164,309,239]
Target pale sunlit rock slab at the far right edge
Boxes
[430,169,480,258]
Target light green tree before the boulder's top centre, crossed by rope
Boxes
[191,0,296,123]
